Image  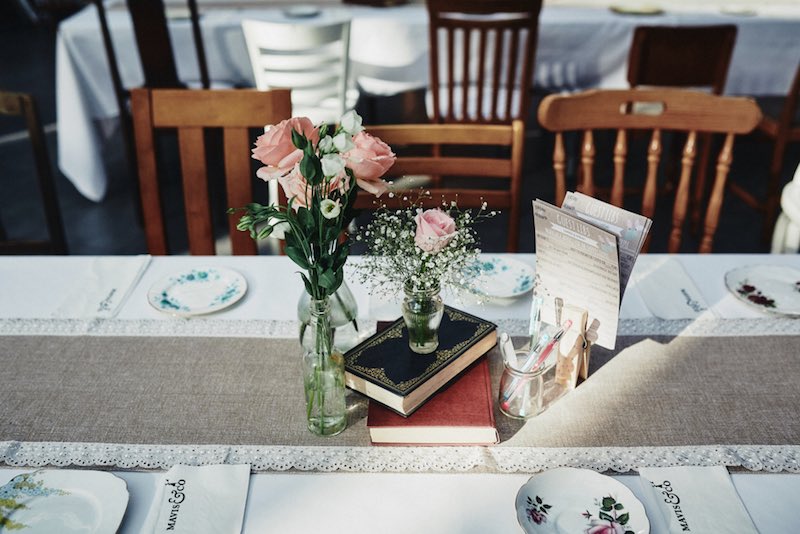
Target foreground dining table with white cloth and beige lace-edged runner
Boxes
[0,254,800,534]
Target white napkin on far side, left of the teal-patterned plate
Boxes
[53,255,150,319]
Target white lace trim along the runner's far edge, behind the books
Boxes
[0,317,800,338]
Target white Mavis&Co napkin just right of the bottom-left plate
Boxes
[142,464,250,534]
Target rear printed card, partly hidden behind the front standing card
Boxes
[561,191,653,298]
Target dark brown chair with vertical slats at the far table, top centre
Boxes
[427,0,542,123]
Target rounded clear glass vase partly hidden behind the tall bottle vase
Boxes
[297,282,361,353]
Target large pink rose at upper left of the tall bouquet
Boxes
[253,117,319,181]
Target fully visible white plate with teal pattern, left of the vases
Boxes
[147,267,247,317]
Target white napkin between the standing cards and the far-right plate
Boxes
[634,257,713,319]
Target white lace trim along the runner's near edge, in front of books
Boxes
[0,441,800,473]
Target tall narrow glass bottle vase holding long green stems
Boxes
[302,298,347,436]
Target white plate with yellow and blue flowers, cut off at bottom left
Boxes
[0,469,128,534]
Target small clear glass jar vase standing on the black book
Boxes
[402,280,444,354]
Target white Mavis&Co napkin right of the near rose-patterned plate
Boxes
[639,466,758,534]
